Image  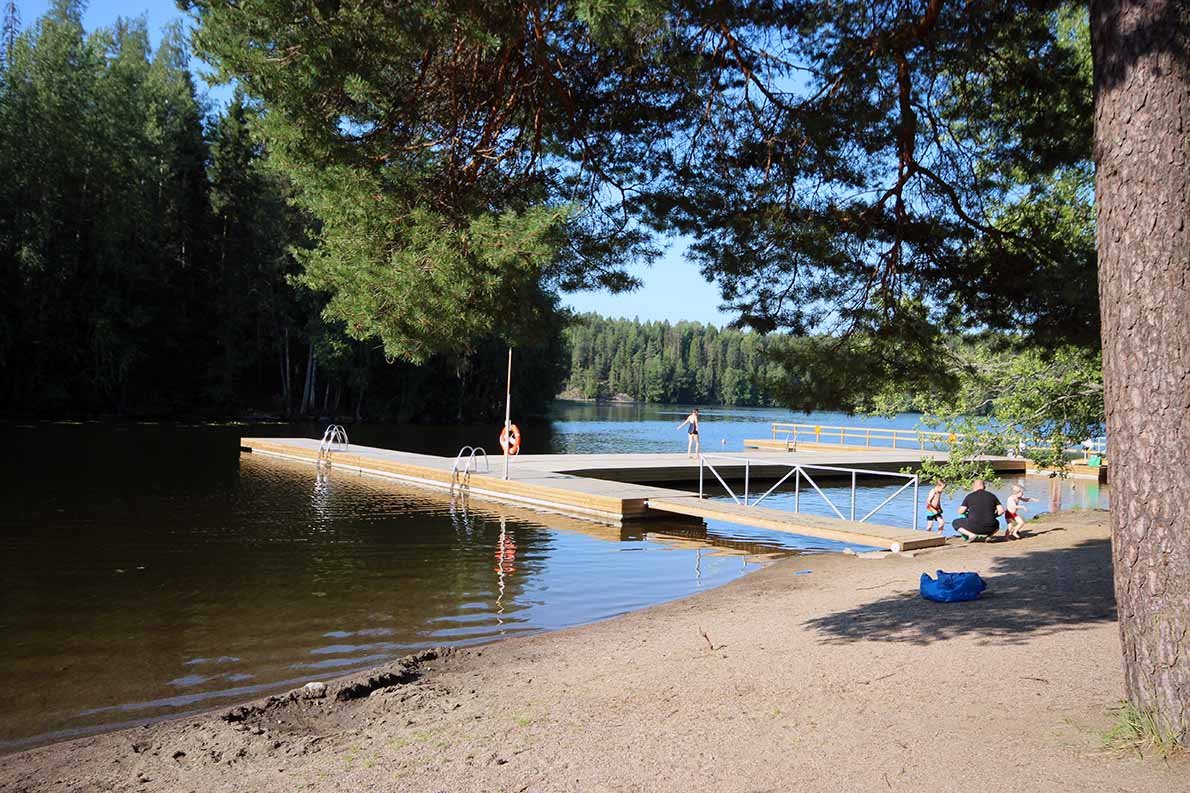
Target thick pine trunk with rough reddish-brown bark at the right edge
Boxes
[1091,0,1190,742]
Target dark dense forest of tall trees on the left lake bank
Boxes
[0,1,565,420]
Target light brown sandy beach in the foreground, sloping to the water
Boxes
[0,512,1190,793]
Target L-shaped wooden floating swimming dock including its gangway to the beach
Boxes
[240,438,1023,551]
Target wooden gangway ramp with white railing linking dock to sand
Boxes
[649,495,946,551]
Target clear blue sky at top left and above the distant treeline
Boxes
[17,0,731,325]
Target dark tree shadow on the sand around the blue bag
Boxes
[806,539,1116,644]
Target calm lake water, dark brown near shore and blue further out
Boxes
[0,404,1106,751]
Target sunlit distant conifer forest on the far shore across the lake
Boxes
[565,314,778,405]
